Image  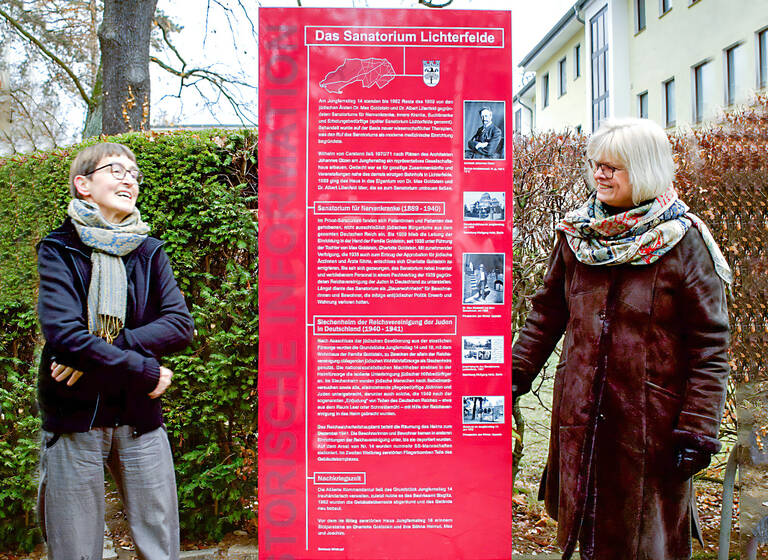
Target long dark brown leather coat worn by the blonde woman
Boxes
[512,227,729,560]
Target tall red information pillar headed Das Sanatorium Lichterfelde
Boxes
[258,8,512,560]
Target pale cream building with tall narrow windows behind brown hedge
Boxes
[514,0,768,133]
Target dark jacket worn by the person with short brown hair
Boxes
[37,218,194,435]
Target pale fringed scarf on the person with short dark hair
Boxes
[67,199,149,344]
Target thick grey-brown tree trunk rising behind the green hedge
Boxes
[99,0,157,135]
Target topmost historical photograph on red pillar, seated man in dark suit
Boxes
[464,101,506,159]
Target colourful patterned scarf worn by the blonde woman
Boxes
[557,187,733,285]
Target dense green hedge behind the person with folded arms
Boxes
[0,131,258,550]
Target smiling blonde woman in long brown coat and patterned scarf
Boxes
[512,119,731,560]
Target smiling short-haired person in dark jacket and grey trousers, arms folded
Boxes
[38,143,193,560]
